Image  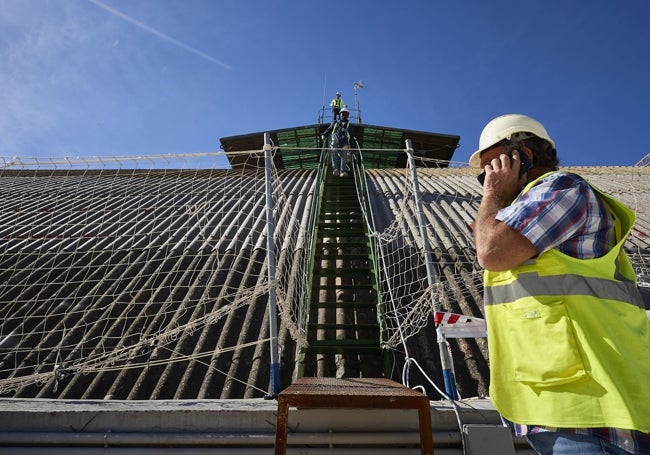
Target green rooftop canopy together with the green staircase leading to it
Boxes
[221,124,460,377]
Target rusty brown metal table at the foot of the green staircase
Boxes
[275,378,433,455]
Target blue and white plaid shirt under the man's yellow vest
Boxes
[496,172,650,454]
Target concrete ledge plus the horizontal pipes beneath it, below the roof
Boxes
[0,399,532,455]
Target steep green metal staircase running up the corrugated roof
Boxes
[297,151,385,377]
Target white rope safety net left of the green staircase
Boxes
[0,152,313,399]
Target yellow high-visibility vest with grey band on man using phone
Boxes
[484,173,650,433]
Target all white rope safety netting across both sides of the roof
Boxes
[0,151,650,399]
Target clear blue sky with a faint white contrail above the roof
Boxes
[0,0,650,165]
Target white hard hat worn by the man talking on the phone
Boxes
[469,114,555,168]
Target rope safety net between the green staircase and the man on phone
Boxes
[369,166,482,348]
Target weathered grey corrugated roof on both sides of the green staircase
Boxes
[0,166,650,400]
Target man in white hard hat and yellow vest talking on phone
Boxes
[470,114,650,455]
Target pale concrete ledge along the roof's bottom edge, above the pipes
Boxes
[0,398,500,433]
